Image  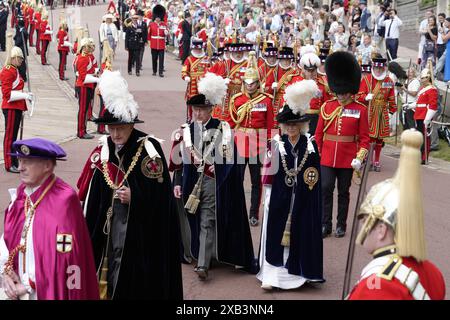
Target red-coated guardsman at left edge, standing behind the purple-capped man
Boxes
[0,34,33,173]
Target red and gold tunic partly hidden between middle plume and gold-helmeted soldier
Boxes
[208,59,247,123]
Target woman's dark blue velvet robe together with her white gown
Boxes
[257,129,325,289]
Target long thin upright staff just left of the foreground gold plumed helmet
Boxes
[342,144,373,300]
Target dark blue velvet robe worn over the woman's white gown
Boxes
[266,135,324,282]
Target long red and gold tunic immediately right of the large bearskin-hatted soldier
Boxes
[357,74,397,139]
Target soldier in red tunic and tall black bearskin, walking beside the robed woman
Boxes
[315,51,369,238]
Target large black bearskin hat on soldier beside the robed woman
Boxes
[325,51,361,94]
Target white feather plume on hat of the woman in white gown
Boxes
[284,80,319,115]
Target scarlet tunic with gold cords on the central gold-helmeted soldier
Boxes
[230,93,274,158]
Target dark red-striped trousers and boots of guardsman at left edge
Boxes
[2,109,22,170]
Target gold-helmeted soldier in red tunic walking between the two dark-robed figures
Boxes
[229,51,274,226]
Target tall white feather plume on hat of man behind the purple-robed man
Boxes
[98,70,139,122]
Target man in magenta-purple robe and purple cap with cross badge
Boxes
[0,138,99,300]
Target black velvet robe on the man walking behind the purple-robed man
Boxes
[80,129,183,299]
